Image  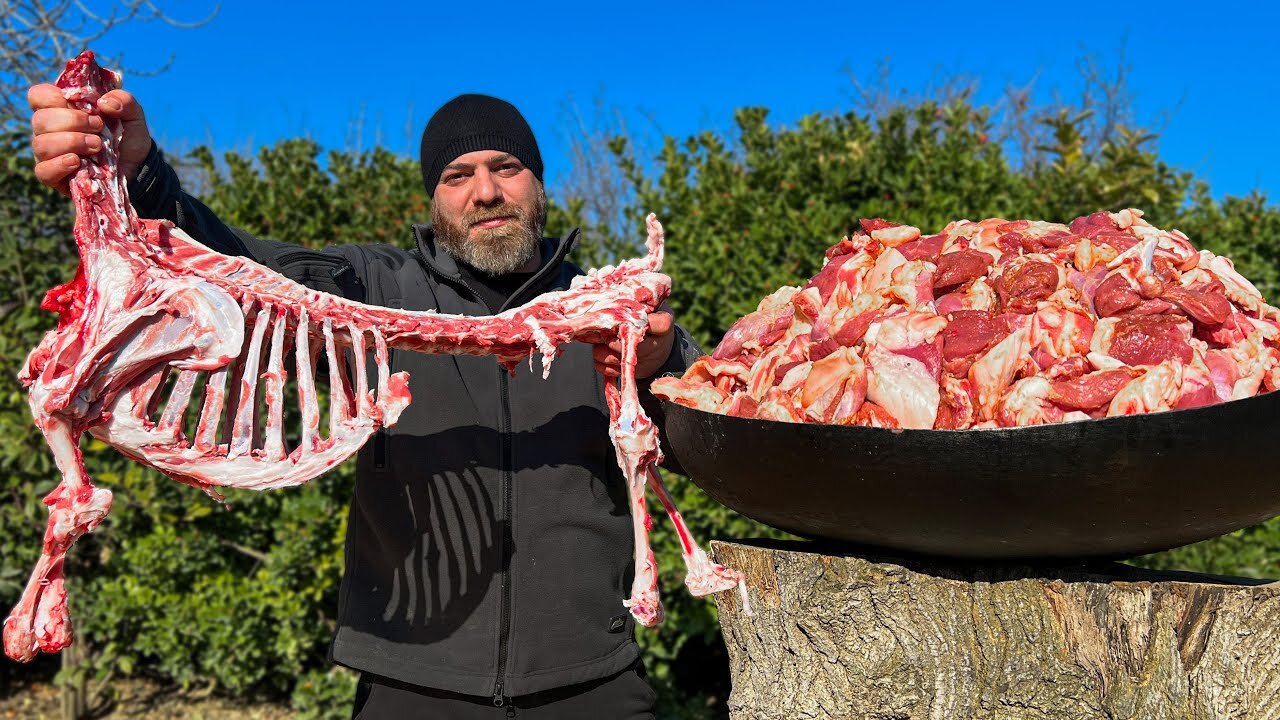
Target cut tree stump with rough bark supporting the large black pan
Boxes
[712,541,1280,720]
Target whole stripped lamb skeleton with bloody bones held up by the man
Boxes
[4,51,742,661]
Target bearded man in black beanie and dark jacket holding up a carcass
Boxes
[28,85,700,720]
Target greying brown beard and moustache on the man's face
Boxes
[431,183,547,275]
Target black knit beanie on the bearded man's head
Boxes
[420,94,543,197]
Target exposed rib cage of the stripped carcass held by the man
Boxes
[88,302,410,489]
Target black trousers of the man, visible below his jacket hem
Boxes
[352,661,658,720]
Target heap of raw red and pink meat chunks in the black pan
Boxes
[654,209,1280,429]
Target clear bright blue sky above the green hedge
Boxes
[95,0,1280,199]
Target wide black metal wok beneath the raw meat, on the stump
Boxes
[663,392,1280,559]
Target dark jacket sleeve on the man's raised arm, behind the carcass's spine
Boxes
[128,141,365,301]
